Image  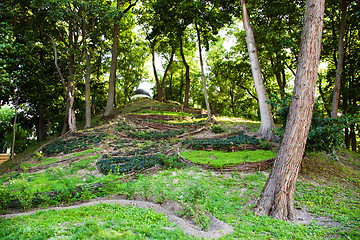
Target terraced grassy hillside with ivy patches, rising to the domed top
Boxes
[0,99,360,239]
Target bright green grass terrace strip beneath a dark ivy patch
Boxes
[181,150,276,168]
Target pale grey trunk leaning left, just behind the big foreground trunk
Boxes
[241,0,275,139]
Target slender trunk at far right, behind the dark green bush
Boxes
[331,0,347,118]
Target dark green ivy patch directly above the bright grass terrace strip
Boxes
[183,133,260,151]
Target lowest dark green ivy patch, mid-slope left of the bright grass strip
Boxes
[96,155,161,174]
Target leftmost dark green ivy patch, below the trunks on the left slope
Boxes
[42,134,107,156]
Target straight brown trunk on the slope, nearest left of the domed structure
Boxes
[104,0,121,117]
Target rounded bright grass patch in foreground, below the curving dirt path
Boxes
[0,204,192,240]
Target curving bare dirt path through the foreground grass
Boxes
[3,197,234,239]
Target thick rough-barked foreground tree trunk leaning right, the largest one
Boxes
[254,0,325,221]
